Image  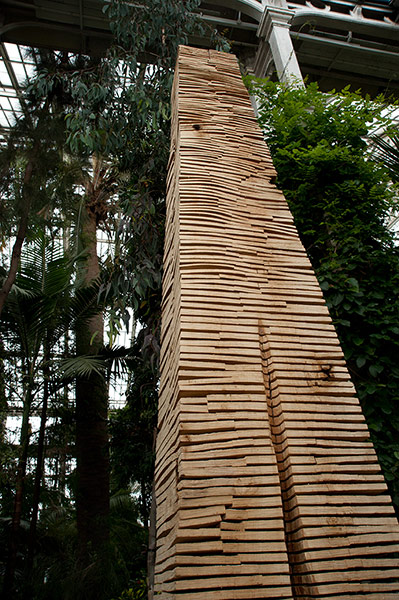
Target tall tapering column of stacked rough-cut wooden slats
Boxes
[155,47,399,600]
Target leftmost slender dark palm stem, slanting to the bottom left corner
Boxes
[3,383,32,598]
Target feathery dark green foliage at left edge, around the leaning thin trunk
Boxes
[0,73,76,251]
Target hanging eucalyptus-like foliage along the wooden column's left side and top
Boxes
[22,0,226,358]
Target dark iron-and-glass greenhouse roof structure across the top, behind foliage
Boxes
[0,0,399,137]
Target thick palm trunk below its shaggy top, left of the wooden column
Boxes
[76,211,109,561]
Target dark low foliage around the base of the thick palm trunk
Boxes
[26,494,147,600]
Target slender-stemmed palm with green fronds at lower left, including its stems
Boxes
[0,233,104,597]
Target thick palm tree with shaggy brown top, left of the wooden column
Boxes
[75,156,116,562]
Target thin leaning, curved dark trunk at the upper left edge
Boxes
[0,159,33,315]
